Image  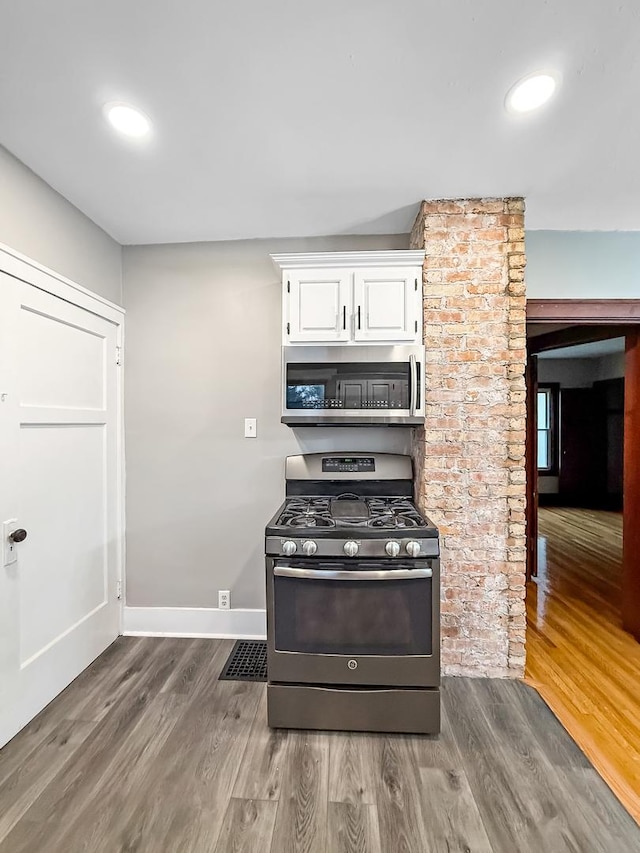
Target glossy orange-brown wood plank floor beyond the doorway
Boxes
[526,507,640,824]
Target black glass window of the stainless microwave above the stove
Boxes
[287,361,411,410]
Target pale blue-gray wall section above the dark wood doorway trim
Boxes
[526,231,640,299]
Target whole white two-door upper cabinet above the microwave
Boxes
[271,251,424,346]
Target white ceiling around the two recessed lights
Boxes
[0,0,640,243]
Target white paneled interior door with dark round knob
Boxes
[0,273,122,746]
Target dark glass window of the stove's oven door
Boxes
[273,571,432,656]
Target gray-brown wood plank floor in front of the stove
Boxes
[0,638,640,853]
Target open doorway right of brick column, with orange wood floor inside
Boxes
[526,308,640,820]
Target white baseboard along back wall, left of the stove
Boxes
[122,607,267,640]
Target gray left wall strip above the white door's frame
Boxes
[0,146,122,305]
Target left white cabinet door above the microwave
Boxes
[285,269,351,343]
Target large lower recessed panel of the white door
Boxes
[18,424,108,666]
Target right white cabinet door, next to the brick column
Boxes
[354,267,422,342]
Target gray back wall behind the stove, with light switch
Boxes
[123,235,410,607]
